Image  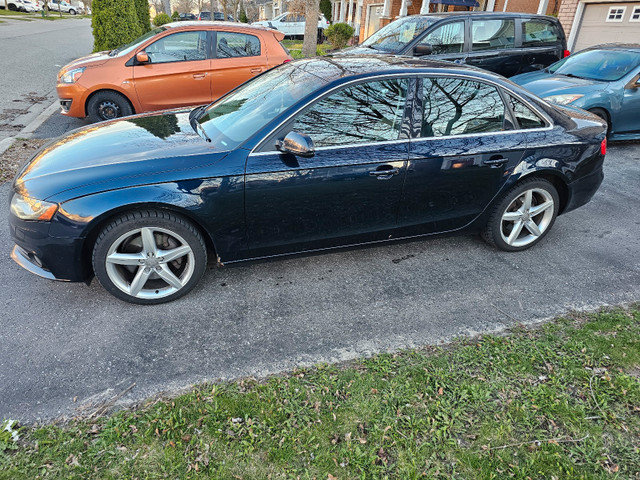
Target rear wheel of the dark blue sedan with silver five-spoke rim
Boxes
[482,178,560,252]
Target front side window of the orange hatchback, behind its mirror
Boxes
[144,32,207,63]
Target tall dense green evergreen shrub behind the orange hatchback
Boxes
[91,0,142,52]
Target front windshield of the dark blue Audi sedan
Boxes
[198,61,328,150]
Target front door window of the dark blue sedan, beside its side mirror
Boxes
[292,79,407,147]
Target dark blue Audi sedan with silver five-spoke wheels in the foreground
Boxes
[10,57,606,304]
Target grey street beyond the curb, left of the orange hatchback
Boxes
[0,17,93,140]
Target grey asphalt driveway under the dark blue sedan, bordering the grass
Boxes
[0,144,640,421]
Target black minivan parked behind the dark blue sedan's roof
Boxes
[340,12,569,77]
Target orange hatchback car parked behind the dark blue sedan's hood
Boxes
[57,22,291,121]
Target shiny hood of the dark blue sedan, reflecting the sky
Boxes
[14,112,228,202]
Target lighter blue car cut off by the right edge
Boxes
[511,44,640,140]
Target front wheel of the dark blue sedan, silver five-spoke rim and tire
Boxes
[92,210,207,305]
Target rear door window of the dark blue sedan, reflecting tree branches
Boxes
[420,78,504,137]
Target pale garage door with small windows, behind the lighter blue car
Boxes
[573,2,640,52]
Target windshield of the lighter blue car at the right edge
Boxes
[549,50,640,82]
